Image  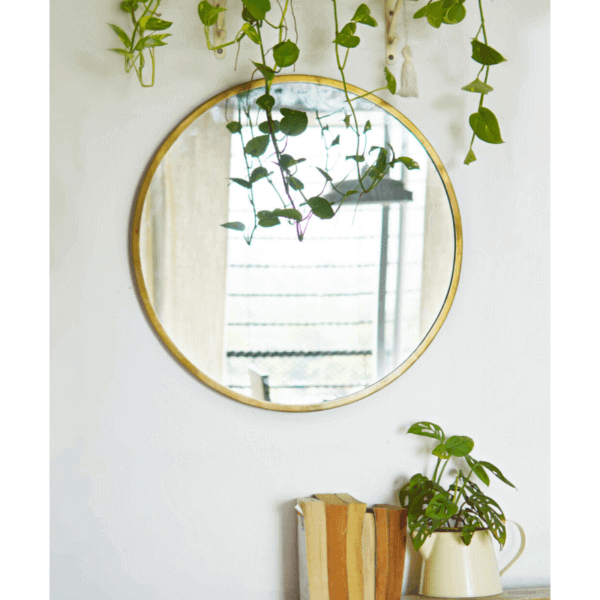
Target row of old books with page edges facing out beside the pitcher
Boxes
[296,494,407,600]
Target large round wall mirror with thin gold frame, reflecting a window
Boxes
[132,76,462,412]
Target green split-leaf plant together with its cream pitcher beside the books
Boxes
[398,421,525,598]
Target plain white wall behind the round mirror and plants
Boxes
[51,0,550,600]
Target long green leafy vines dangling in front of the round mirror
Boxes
[198,0,419,244]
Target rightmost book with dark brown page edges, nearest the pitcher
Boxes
[373,504,408,600]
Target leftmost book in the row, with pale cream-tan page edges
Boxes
[296,498,330,600]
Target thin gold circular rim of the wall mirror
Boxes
[131,75,463,412]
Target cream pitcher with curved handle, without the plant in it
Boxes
[419,521,525,598]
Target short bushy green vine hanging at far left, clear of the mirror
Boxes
[109,0,173,87]
